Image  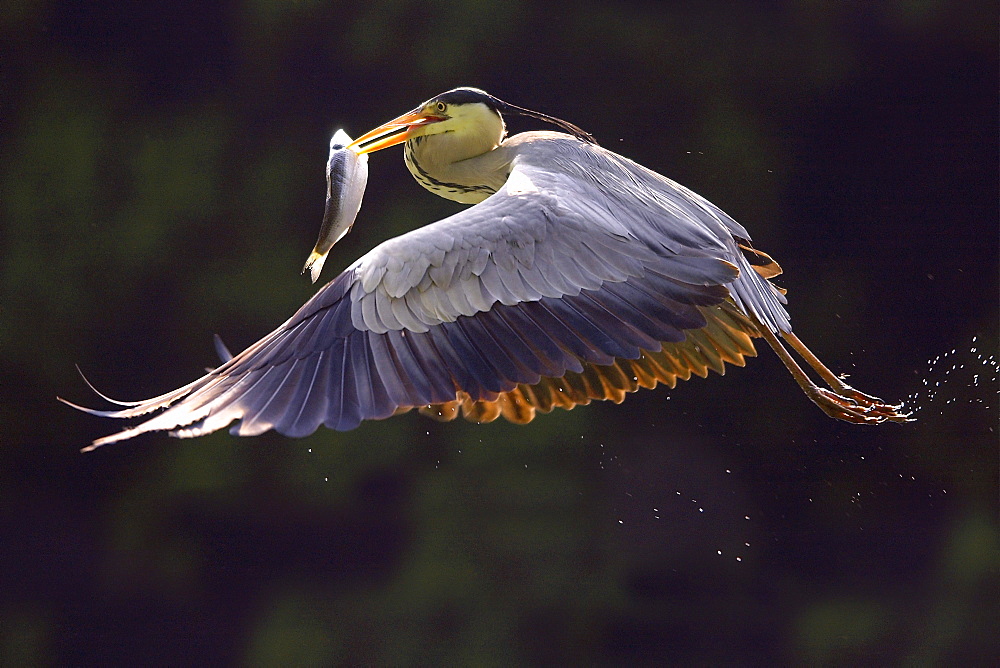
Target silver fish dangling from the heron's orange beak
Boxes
[302,130,368,283]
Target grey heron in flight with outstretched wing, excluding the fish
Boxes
[68,88,908,449]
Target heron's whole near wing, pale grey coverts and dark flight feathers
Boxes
[74,142,787,447]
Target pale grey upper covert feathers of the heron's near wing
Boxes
[353,155,752,332]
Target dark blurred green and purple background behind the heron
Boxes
[0,0,1000,665]
